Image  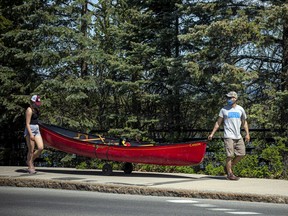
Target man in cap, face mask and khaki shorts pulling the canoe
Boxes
[208,91,250,180]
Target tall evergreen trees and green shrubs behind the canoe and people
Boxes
[0,0,288,178]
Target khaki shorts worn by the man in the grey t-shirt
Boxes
[224,138,246,157]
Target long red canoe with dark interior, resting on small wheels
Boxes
[40,123,207,172]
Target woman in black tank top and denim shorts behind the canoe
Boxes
[24,95,44,174]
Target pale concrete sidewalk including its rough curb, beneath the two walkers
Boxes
[0,166,288,204]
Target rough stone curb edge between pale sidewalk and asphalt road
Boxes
[0,177,288,204]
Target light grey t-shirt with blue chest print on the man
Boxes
[219,105,247,139]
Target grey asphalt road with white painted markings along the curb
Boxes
[0,187,288,216]
